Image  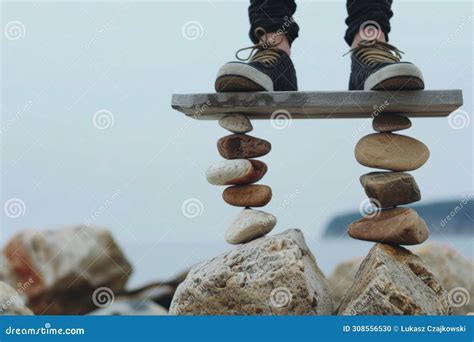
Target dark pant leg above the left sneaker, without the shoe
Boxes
[249,0,299,44]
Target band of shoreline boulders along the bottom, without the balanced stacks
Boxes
[0,226,474,315]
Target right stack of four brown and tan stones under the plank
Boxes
[348,114,430,245]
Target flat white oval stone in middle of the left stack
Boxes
[206,159,253,185]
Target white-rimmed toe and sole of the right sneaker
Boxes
[364,64,425,90]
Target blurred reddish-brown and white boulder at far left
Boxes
[3,226,132,314]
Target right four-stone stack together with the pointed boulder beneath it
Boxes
[336,114,451,315]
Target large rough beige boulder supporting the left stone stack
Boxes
[170,229,333,315]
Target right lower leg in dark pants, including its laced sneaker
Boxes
[344,0,425,90]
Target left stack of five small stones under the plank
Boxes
[206,114,276,244]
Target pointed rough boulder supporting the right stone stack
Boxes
[337,244,451,315]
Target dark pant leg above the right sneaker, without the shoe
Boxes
[344,0,393,45]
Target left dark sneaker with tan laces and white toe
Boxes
[215,29,298,92]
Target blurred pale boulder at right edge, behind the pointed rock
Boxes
[416,243,474,315]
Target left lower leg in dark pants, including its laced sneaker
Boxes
[215,0,299,92]
